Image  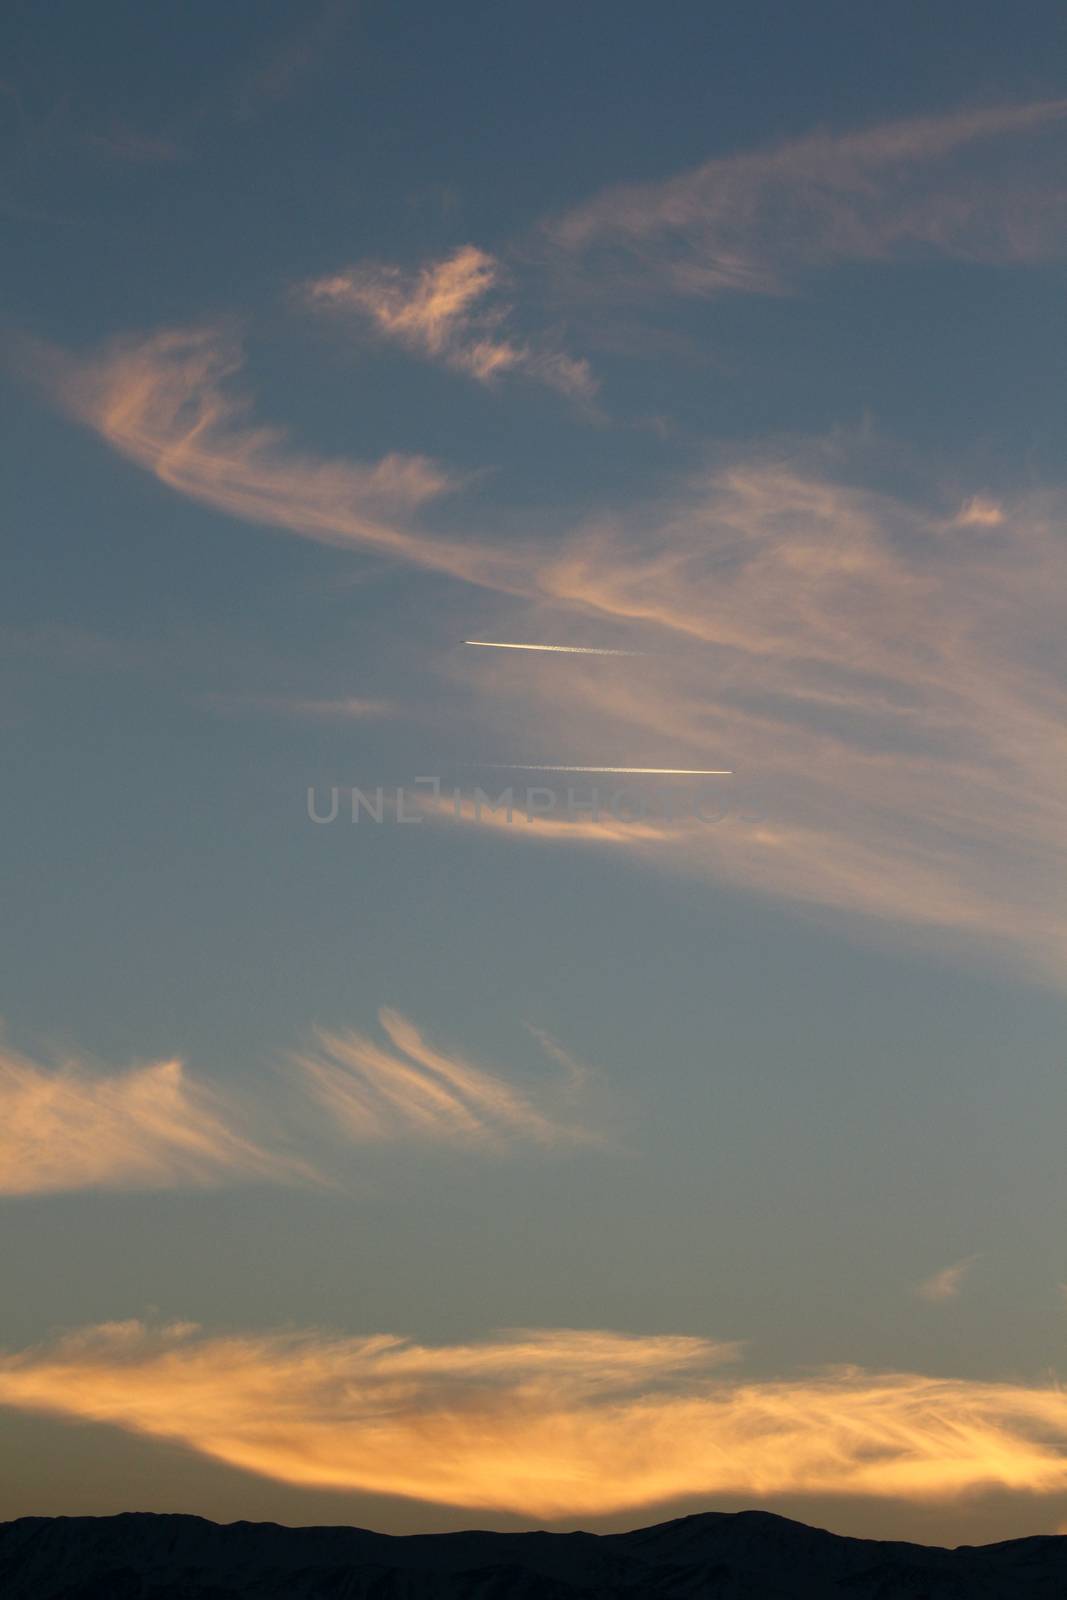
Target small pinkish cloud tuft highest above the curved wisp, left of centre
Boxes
[301,245,597,400]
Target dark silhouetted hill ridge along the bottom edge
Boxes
[0,1510,1067,1600]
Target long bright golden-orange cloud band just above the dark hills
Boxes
[0,1322,1067,1518]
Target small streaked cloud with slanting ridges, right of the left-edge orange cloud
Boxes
[294,1010,595,1149]
